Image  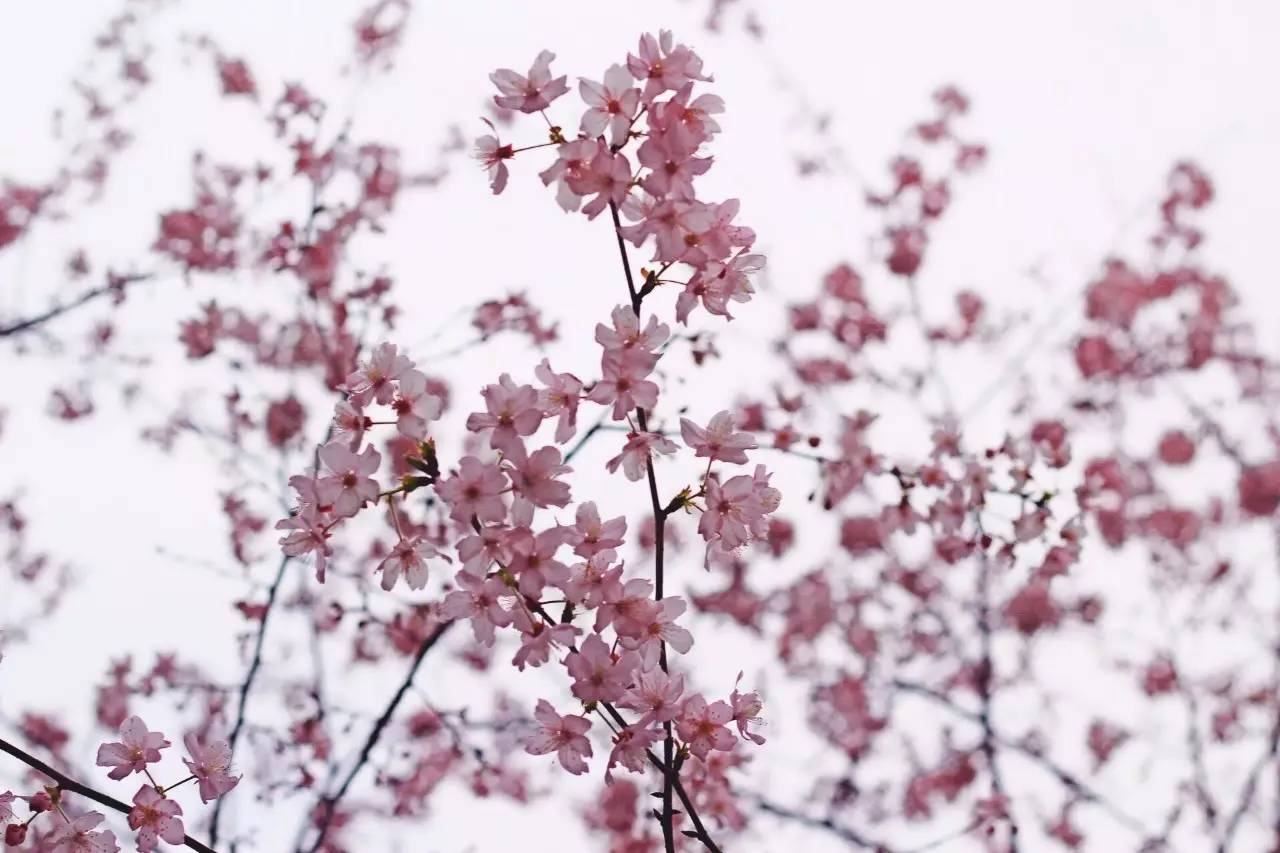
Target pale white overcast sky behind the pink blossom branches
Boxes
[0,0,1280,850]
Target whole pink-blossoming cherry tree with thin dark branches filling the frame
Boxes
[0,0,1280,853]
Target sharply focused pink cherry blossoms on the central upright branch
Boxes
[278,32,781,834]
